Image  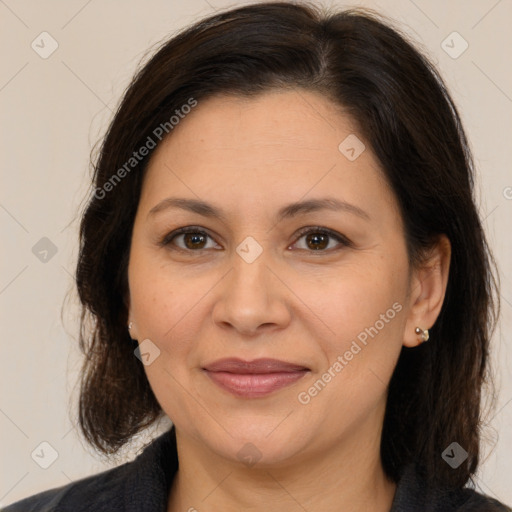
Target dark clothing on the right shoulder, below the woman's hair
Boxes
[391,465,512,512]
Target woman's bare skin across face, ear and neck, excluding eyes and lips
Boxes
[128,90,450,512]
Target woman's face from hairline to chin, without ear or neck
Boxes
[129,91,411,464]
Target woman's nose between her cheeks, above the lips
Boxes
[213,251,292,337]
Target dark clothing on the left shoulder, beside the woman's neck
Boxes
[1,429,178,512]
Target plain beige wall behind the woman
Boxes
[0,0,512,505]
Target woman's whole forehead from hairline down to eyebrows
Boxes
[141,90,395,225]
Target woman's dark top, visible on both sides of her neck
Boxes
[2,427,512,512]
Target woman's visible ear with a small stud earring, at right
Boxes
[403,235,451,347]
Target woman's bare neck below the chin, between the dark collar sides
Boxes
[168,414,396,512]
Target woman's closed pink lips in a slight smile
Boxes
[203,358,310,398]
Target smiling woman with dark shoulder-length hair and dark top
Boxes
[6,3,508,512]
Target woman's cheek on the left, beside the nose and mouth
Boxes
[129,246,222,384]
